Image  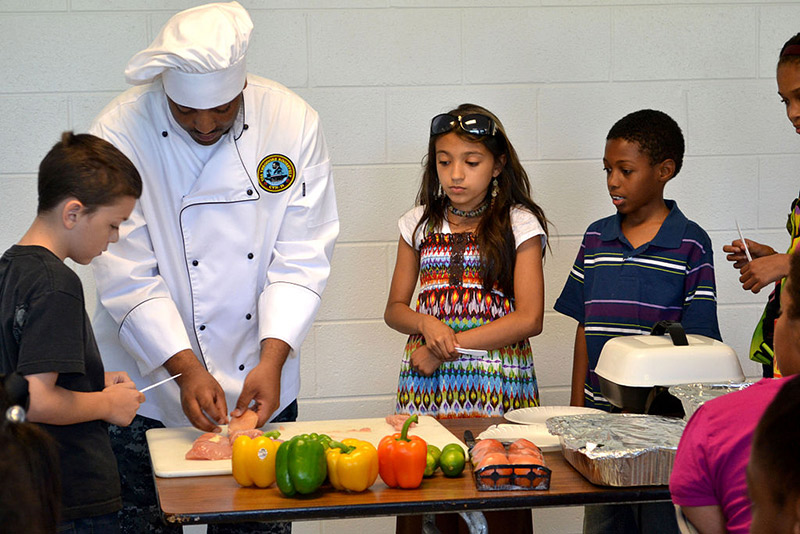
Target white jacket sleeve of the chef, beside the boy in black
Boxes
[92,202,191,376]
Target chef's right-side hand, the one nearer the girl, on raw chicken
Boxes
[231,338,291,427]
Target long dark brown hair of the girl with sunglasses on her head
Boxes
[414,104,548,298]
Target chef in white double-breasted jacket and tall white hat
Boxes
[91,2,339,534]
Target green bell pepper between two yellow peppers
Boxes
[275,434,331,497]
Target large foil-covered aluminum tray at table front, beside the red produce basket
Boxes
[547,414,686,487]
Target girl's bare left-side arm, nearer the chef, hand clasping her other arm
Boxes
[383,237,458,360]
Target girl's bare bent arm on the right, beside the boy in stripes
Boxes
[456,235,544,349]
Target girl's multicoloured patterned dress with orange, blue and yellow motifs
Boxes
[396,233,539,418]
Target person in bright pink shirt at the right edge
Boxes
[669,248,800,534]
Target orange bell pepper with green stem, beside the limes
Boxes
[378,415,428,489]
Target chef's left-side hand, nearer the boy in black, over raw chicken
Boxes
[164,349,228,432]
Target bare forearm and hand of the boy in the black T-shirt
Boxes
[25,373,144,426]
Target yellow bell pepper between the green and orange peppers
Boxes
[325,438,378,491]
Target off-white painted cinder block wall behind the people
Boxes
[0,0,800,533]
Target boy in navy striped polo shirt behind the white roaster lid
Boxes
[555,109,721,411]
